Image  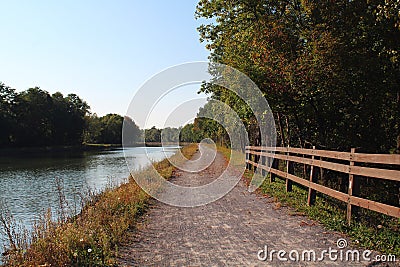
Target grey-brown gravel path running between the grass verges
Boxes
[119,148,374,266]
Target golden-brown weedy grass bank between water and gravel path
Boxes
[0,144,197,266]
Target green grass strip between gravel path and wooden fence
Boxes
[218,147,400,258]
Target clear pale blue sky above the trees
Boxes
[0,0,209,127]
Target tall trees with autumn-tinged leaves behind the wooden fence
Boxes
[192,0,400,153]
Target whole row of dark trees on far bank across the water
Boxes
[0,82,143,148]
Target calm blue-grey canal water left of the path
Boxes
[0,147,178,251]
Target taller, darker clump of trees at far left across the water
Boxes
[0,83,89,147]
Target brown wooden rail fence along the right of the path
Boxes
[246,146,400,223]
